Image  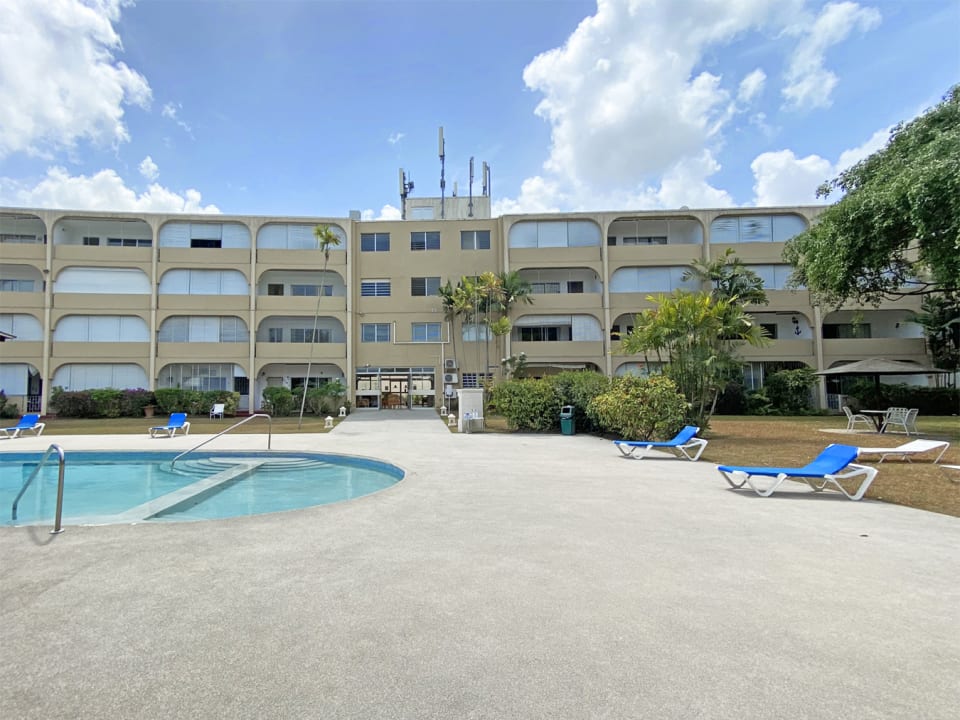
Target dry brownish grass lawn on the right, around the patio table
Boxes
[487,416,960,517]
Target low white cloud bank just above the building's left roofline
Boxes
[0,167,220,213]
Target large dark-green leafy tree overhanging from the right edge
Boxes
[784,85,960,305]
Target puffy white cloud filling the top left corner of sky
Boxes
[0,0,151,158]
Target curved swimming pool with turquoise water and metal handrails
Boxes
[0,451,404,526]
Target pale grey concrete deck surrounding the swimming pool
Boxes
[0,412,960,720]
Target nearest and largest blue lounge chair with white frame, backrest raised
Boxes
[717,445,877,500]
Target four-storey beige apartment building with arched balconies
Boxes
[0,197,927,412]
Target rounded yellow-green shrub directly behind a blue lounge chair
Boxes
[587,375,690,440]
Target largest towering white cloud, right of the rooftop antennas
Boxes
[495,0,803,212]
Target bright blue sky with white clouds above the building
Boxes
[0,0,960,219]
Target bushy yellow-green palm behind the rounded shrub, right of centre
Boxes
[620,290,769,428]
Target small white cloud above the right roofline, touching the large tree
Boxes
[750,127,892,206]
